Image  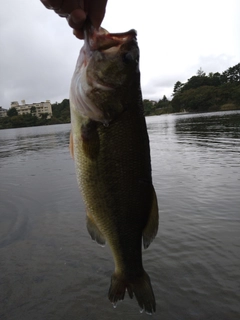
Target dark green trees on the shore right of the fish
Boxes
[143,63,240,115]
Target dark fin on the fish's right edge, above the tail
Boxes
[143,186,158,249]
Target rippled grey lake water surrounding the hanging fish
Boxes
[0,112,240,320]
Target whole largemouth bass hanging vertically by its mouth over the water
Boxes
[70,28,158,314]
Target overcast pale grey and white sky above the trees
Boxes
[0,0,240,109]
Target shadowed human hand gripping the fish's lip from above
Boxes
[41,0,107,39]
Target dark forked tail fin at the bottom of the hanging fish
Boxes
[108,270,156,314]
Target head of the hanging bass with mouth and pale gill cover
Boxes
[70,28,140,124]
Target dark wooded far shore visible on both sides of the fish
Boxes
[0,63,240,129]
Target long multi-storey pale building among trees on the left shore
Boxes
[11,100,52,119]
